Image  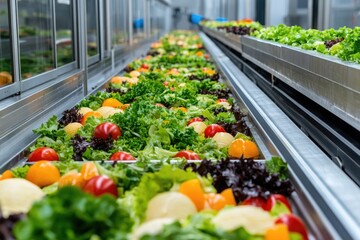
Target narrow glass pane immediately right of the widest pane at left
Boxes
[55,0,74,67]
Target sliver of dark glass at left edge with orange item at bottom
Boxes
[0,0,13,87]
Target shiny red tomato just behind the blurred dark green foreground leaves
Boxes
[83,176,119,197]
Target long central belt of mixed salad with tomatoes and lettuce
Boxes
[0,31,308,240]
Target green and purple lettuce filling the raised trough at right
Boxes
[201,19,360,63]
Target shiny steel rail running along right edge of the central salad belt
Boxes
[200,33,360,239]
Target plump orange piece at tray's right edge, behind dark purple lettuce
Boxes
[228,139,259,158]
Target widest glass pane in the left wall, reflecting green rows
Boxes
[18,0,54,79]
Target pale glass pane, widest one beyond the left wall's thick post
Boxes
[110,0,128,47]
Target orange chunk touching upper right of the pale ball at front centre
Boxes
[179,179,205,211]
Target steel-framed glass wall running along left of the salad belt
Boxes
[0,0,171,172]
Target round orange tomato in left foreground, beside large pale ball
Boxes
[26,160,60,187]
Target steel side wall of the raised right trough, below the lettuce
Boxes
[204,28,360,130]
